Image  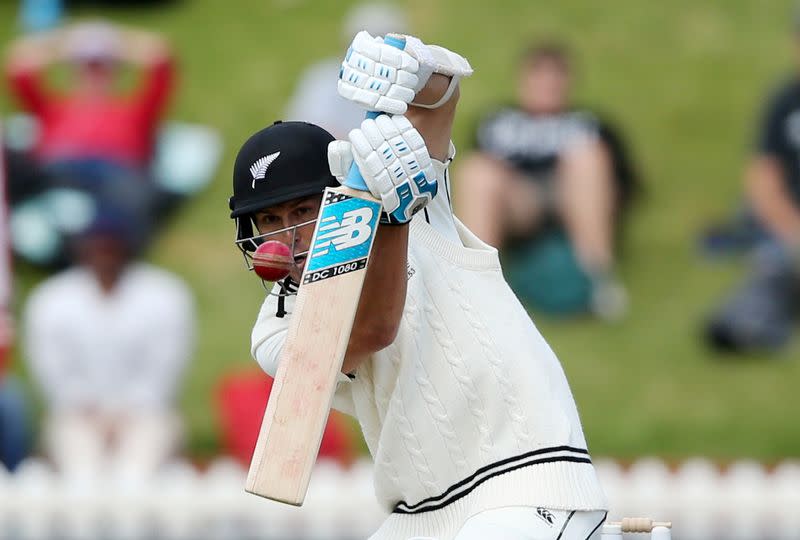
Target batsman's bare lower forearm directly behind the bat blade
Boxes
[342,225,408,373]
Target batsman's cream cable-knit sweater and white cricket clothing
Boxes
[252,177,606,540]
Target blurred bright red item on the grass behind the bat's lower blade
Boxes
[217,369,357,466]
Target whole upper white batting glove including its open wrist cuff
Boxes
[338,31,472,114]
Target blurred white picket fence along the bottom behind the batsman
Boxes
[0,459,800,540]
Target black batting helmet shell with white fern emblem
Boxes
[228,122,339,254]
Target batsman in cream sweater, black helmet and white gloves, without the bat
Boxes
[230,32,606,540]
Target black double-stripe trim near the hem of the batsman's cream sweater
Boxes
[392,446,592,514]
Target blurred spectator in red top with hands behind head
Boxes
[7,22,174,168]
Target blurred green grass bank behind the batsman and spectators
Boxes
[0,0,800,460]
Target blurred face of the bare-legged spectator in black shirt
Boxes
[519,58,570,114]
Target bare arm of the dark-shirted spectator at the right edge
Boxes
[747,157,800,248]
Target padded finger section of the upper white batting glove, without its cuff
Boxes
[338,31,420,114]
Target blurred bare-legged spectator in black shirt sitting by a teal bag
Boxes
[457,44,635,318]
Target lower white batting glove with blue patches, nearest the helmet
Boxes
[328,114,439,224]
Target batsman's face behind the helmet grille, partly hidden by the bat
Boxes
[253,195,322,282]
